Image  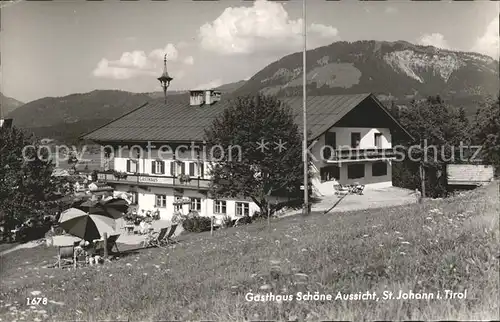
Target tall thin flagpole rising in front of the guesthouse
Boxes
[302,0,309,215]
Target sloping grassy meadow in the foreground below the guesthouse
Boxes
[0,184,500,321]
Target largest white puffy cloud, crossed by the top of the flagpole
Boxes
[198,0,338,55]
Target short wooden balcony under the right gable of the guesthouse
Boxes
[324,148,396,163]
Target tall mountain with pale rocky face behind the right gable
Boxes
[235,41,500,112]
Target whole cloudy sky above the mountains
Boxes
[0,0,500,102]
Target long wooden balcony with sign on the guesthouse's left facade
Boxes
[97,172,210,190]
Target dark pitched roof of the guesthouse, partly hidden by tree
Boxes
[82,93,410,142]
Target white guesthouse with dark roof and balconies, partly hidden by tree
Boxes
[82,90,414,220]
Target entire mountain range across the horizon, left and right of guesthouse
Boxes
[1,41,500,141]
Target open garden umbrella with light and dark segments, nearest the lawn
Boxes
[59,208,116,241]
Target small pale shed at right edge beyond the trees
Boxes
[446,164,495,186]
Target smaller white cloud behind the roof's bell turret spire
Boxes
[92,44,194,80]
